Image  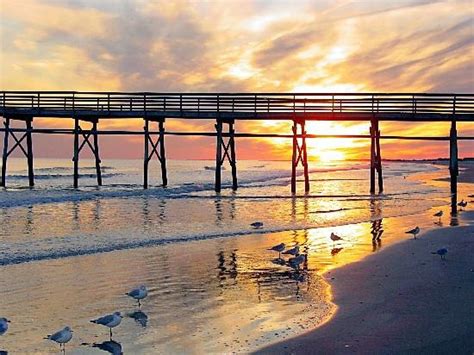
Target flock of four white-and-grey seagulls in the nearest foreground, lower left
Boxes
[0,285,148,351]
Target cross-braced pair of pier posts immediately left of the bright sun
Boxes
[291,120,310,194]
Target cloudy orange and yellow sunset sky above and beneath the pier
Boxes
[0,0,474,160]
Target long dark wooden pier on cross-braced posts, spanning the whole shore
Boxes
[0,91,474,199]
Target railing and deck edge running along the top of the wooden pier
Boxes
[0,91,474,120]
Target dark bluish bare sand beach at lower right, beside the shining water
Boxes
[255,211,474,354]
